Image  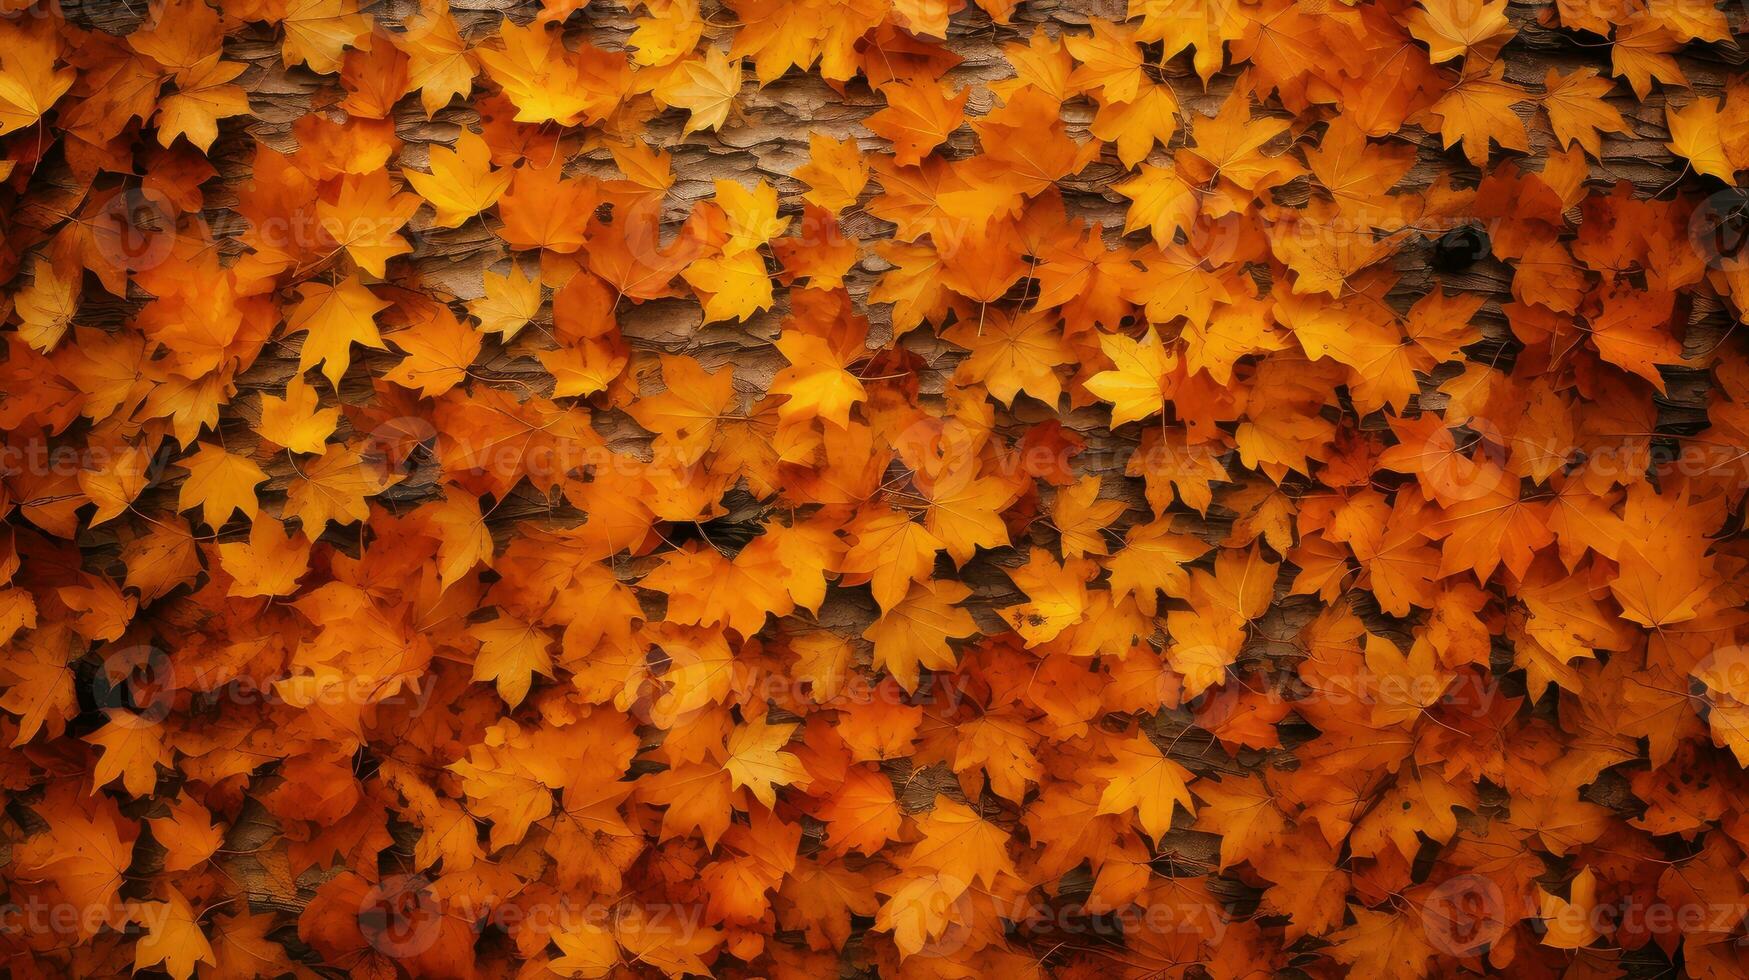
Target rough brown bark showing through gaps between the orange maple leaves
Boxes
[47,0,1746,966]
